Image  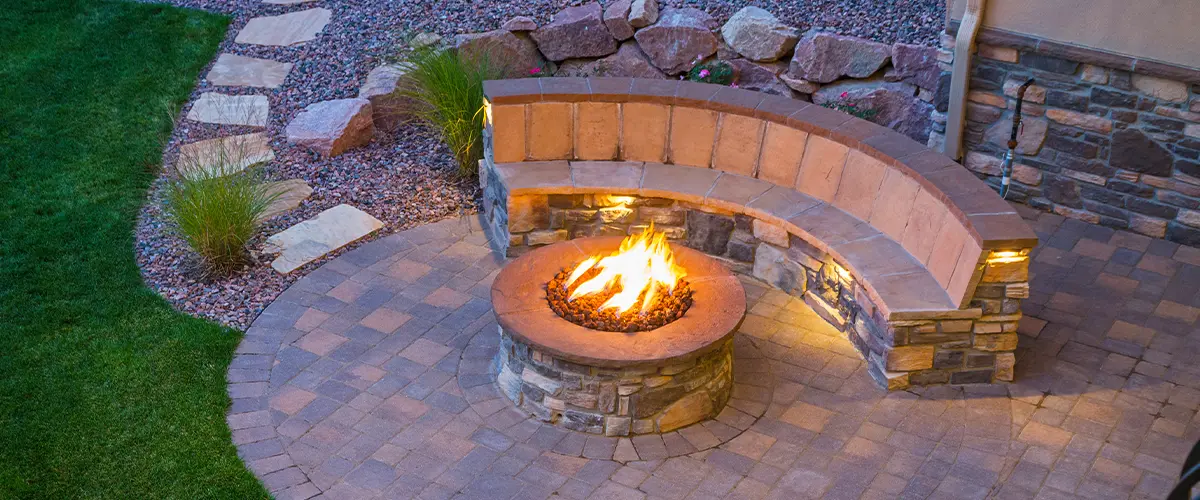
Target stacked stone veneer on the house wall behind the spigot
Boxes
[934,27,1200,246]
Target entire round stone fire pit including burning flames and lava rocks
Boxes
[492,231,745,435]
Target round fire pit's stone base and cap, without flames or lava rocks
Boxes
[492,236,745,435]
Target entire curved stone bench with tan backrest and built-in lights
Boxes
[480,79,1037,388]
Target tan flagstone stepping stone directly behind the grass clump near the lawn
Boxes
[175,133,275,179]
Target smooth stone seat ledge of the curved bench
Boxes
[493,161,960,320]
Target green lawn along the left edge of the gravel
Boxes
[0,0,266,499]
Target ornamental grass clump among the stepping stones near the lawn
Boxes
[167,143,281,275]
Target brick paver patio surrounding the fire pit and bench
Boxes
[228,209,1200,499]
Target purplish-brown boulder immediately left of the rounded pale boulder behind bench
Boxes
[634,8,716,74]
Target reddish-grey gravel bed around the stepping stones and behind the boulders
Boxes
[137,0,944,329]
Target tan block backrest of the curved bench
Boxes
[491,102,1032,305]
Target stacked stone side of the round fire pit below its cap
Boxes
[496,333,733,435]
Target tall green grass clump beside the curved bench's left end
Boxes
[398,48,504,177]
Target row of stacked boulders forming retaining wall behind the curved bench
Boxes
[455,0,949,143]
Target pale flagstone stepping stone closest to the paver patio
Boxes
[265,204,383,275]
